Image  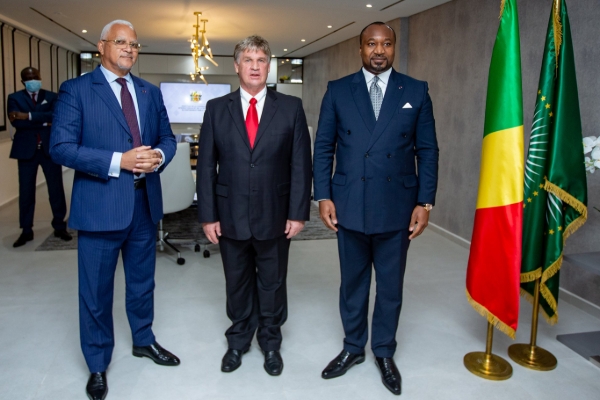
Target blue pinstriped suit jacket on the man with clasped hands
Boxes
[50,68,176,231]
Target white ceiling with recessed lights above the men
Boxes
[0,0,450,57]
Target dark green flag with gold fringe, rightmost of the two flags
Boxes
[521,0,587,324]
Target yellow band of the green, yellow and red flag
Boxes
[477,125,523,209]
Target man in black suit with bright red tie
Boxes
[197,36,311,375]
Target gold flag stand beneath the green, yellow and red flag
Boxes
[463,322,512,381]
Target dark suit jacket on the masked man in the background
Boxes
[6,89,57,160]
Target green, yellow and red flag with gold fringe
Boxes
[467,0,524,338]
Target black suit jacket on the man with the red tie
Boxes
[196,90,312,240]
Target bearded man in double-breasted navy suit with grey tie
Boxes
[313,22,438,395]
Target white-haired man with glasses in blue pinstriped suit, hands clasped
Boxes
[50,20,180,399]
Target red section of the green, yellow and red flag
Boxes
[467,202,523,330]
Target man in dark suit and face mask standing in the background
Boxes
[6,67,72,247]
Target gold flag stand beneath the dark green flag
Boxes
[508,277,558,371]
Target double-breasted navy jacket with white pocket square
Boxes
[313,70,438,234]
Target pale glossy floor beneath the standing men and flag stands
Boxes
[0,173,600,400]
